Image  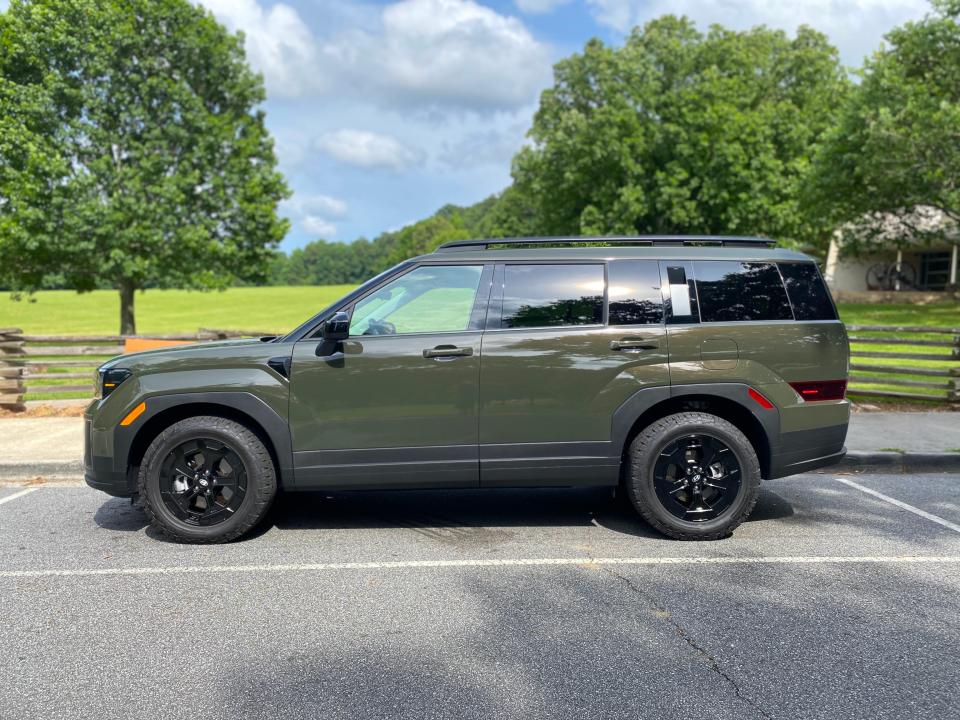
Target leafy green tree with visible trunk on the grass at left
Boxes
[0,0,288,334]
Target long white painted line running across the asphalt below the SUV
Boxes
[0,555,960,578]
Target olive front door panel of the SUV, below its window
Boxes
[290,331,481,487]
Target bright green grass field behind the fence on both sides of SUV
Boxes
[0,285,960,399]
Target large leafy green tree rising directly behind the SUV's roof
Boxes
[513,16,849,248]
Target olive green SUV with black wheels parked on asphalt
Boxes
[84,236,849,542]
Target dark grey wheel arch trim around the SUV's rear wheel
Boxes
[614,383,780,478]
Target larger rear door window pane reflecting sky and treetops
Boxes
[500,265,604,328]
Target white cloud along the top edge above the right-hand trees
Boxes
[587,0,930,65]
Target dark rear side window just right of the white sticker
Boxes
[694,261,793,322]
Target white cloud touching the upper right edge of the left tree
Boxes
[201,0,325,97]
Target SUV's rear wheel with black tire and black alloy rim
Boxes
[626,412,760,540]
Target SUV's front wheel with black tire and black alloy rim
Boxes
[137,416,277,543]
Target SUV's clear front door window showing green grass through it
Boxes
[350,265,483,335]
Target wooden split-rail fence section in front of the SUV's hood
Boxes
[0,328,267,410]
